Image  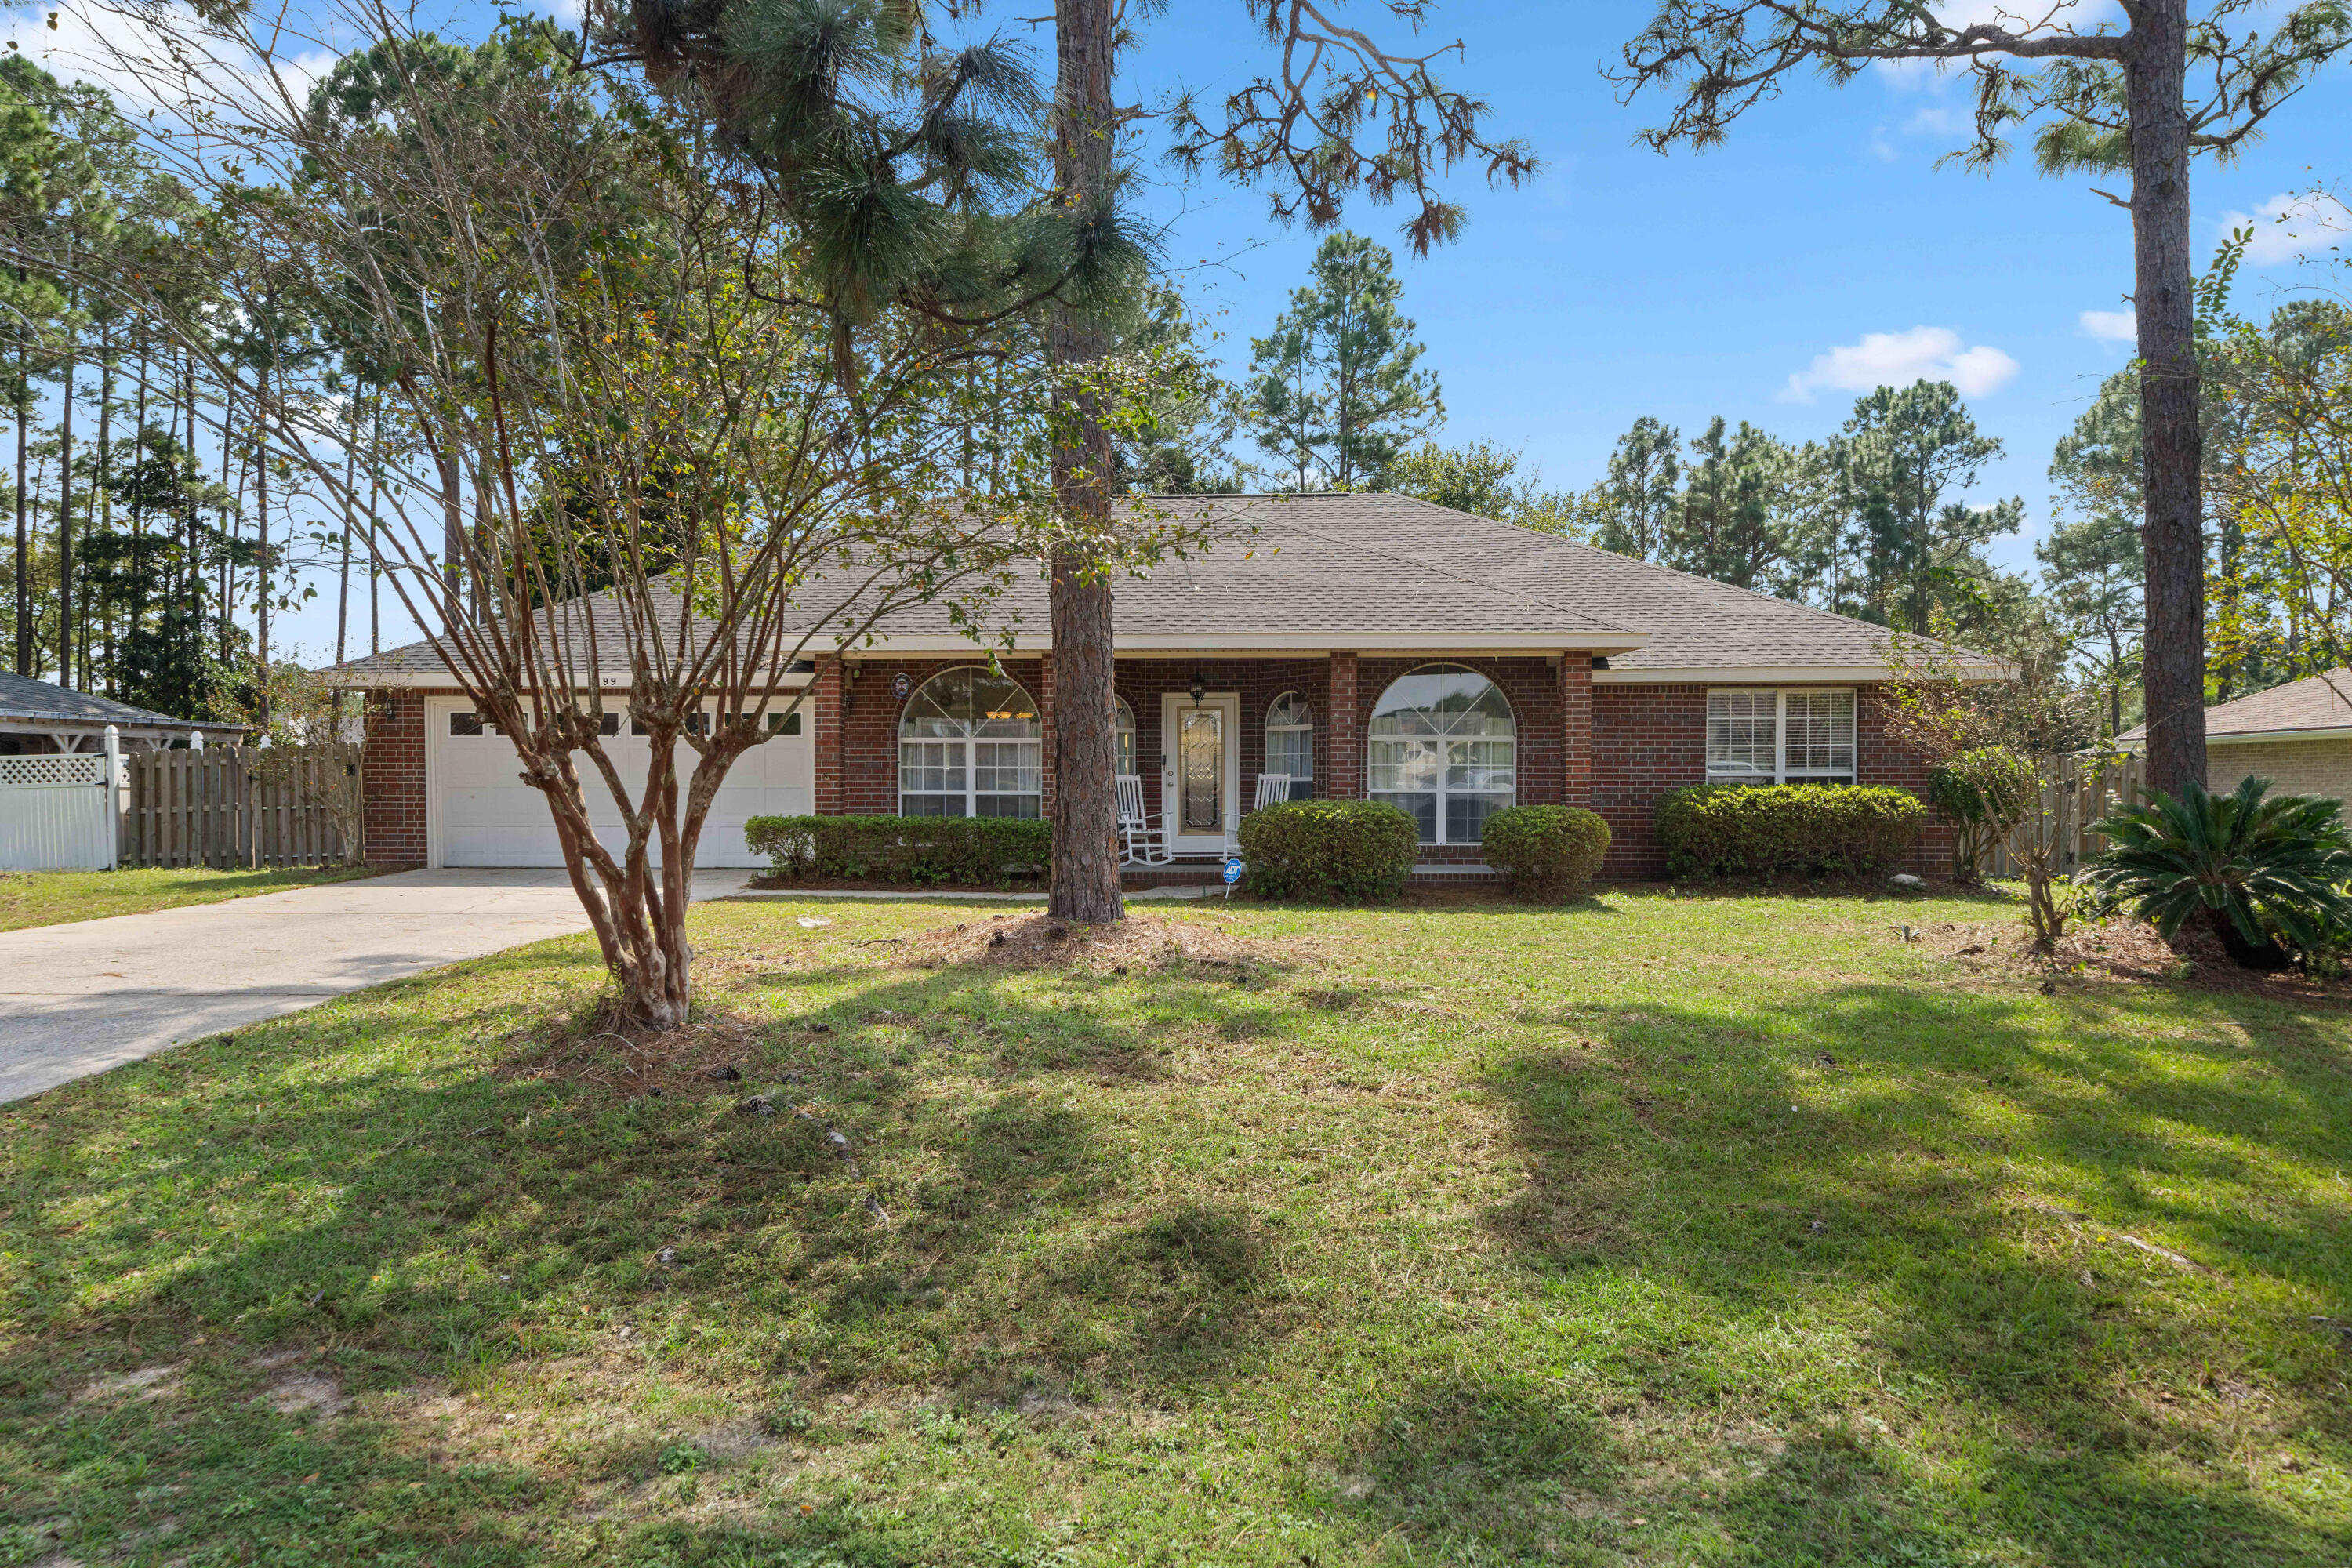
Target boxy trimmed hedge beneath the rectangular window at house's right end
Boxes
[1658,785,1926,877]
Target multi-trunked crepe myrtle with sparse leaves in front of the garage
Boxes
[43,9,1195,1025]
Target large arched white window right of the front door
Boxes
[1369,666,1519,844]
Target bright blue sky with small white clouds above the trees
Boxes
[0,0,2352,652]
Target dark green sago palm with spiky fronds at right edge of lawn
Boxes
[2084,779,2352,968]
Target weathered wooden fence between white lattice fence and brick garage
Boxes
[122,741,360,869]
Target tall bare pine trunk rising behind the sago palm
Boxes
[2124,0,2206,794]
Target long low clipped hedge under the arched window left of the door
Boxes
[743,815,1054,886]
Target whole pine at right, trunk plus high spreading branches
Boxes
[1604,0,2352,792]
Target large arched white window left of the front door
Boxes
[898,668,1044,818]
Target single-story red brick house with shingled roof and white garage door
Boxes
[334,494,1997,874]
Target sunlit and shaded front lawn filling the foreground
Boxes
[0,891,2352,1568]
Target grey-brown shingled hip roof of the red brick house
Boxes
[322,494,1997,684]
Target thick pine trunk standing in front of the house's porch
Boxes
[1047,0,1127,924]
